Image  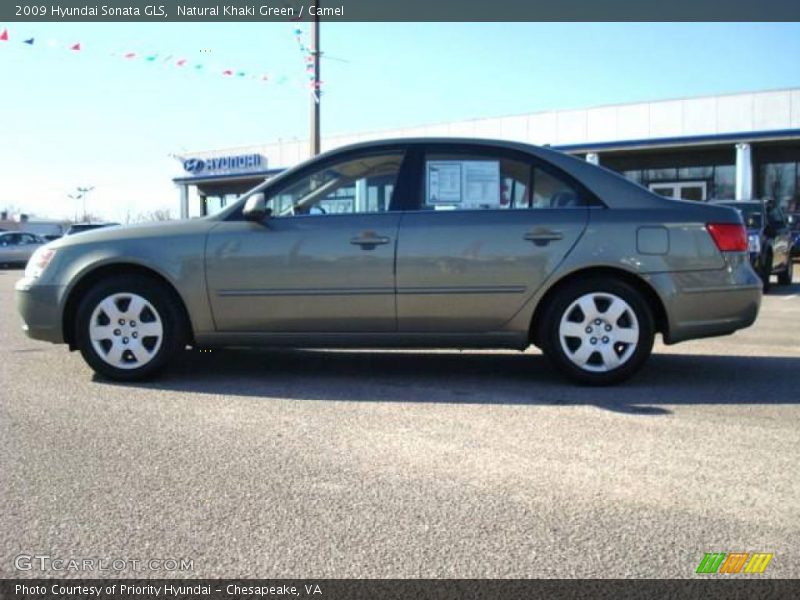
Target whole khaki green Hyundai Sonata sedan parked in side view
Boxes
[16,139,761,384]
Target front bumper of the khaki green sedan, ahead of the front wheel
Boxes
[14,279,64,344]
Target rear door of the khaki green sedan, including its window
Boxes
[397,145,590,333]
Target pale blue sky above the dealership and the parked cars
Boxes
[0,22,800,221]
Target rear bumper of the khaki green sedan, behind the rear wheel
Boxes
[652,254,763,344]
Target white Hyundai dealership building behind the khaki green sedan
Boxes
[173,88,800,217]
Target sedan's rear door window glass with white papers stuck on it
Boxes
[422,153,531,210]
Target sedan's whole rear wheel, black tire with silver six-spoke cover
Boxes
[542,277,655,385]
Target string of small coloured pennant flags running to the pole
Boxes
[0,28,320,93]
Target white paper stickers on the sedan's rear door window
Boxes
[426,160,500,209]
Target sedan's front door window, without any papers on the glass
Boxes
[267,152,403,217]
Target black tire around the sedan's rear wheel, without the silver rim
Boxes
[543,278,655,385]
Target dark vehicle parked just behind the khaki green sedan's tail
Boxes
[714,200,794,292]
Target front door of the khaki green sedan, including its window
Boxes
[206,147,405,332]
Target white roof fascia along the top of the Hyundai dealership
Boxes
[181,88,800,168]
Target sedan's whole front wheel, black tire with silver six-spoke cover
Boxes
[75,274,188,381]
